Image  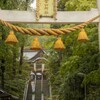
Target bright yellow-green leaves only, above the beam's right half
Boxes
[65,0,96,11]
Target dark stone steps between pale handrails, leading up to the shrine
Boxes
[23,78,49,100]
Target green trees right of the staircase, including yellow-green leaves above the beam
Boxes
[48,0,100,100]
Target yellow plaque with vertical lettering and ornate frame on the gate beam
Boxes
[36,0,57,20]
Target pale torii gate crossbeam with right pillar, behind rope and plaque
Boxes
[0,0,100,50]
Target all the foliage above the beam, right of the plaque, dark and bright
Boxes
[58,0,96,11]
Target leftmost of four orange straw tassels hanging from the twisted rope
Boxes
[5,31,18,45]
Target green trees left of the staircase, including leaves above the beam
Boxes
[0,0,30,100]
